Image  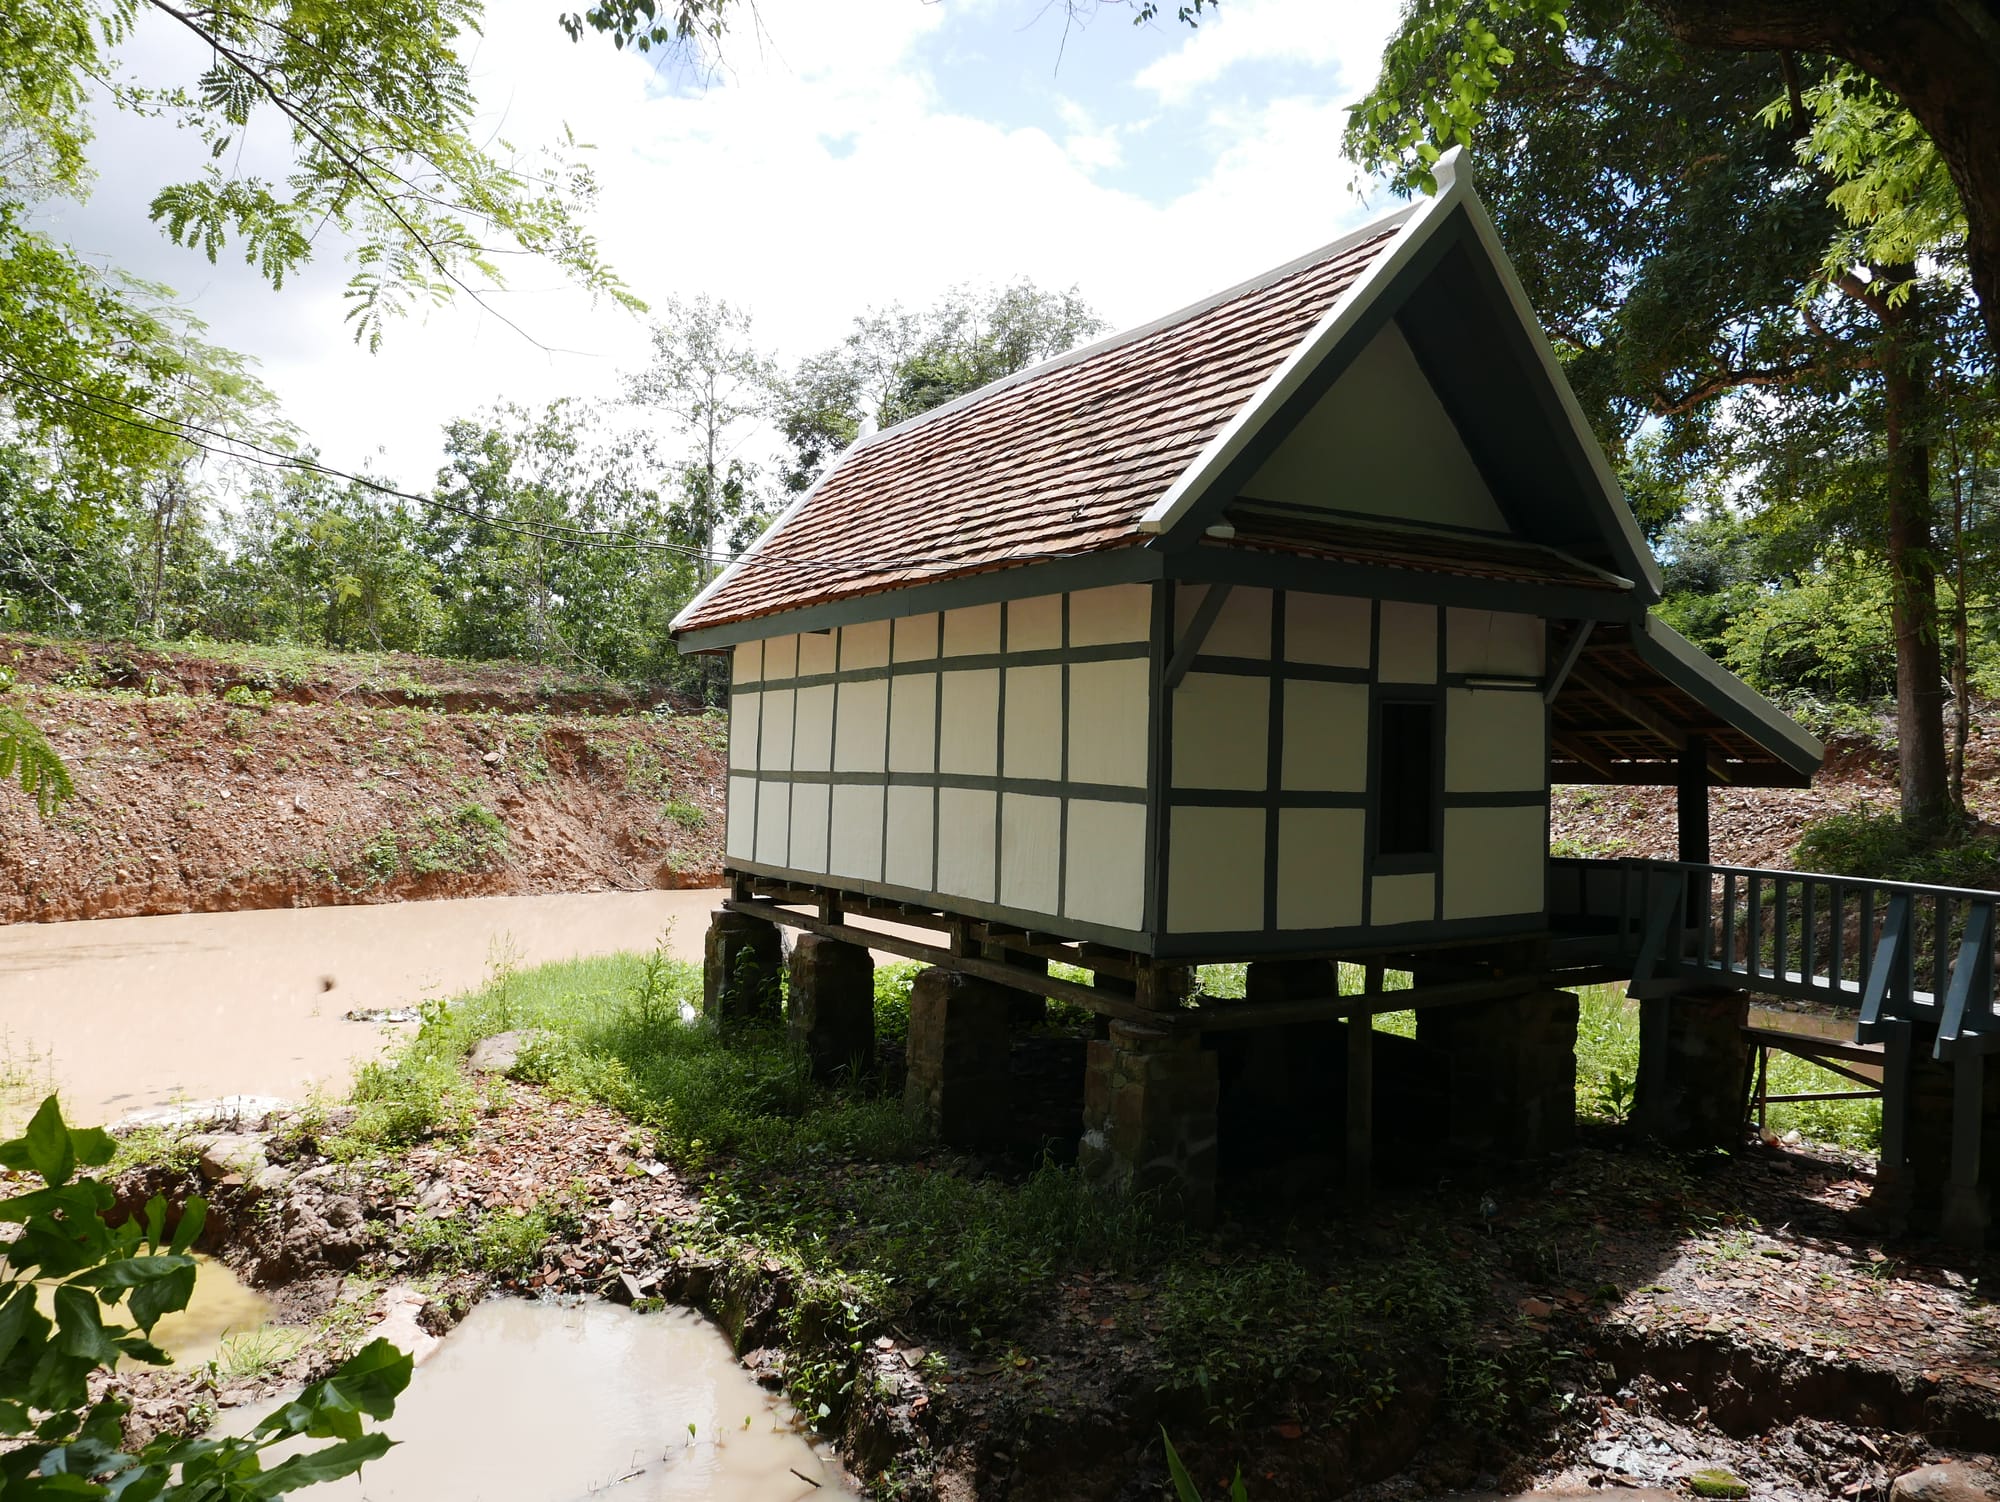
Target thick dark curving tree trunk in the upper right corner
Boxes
[1642,0,2000,350]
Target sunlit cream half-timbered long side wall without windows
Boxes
[728,586,1152,934]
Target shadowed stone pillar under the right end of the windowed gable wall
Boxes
[1416,990,1576,1158]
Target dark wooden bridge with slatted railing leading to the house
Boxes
[1548,858,2000,1240]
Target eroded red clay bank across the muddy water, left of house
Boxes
[0,638,726,922]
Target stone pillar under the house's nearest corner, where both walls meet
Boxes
[1076,1022,1218,1226]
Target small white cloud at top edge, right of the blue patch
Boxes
[1136,0,1400,104]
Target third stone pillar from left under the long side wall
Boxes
[902,966,1008,1148]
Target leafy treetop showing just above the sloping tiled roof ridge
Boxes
[776,278,1106,494]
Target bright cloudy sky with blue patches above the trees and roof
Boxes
[50,0,1398,488]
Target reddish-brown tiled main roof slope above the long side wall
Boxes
[676,218,1402,630]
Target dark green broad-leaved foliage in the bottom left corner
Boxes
[0,1096,410,1502]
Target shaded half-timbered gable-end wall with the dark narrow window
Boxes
[1164,586,1548,942]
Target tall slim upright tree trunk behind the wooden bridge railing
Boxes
[1882,314,1956,836]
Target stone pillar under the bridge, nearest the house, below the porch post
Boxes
[1632,990,1750,1148]
